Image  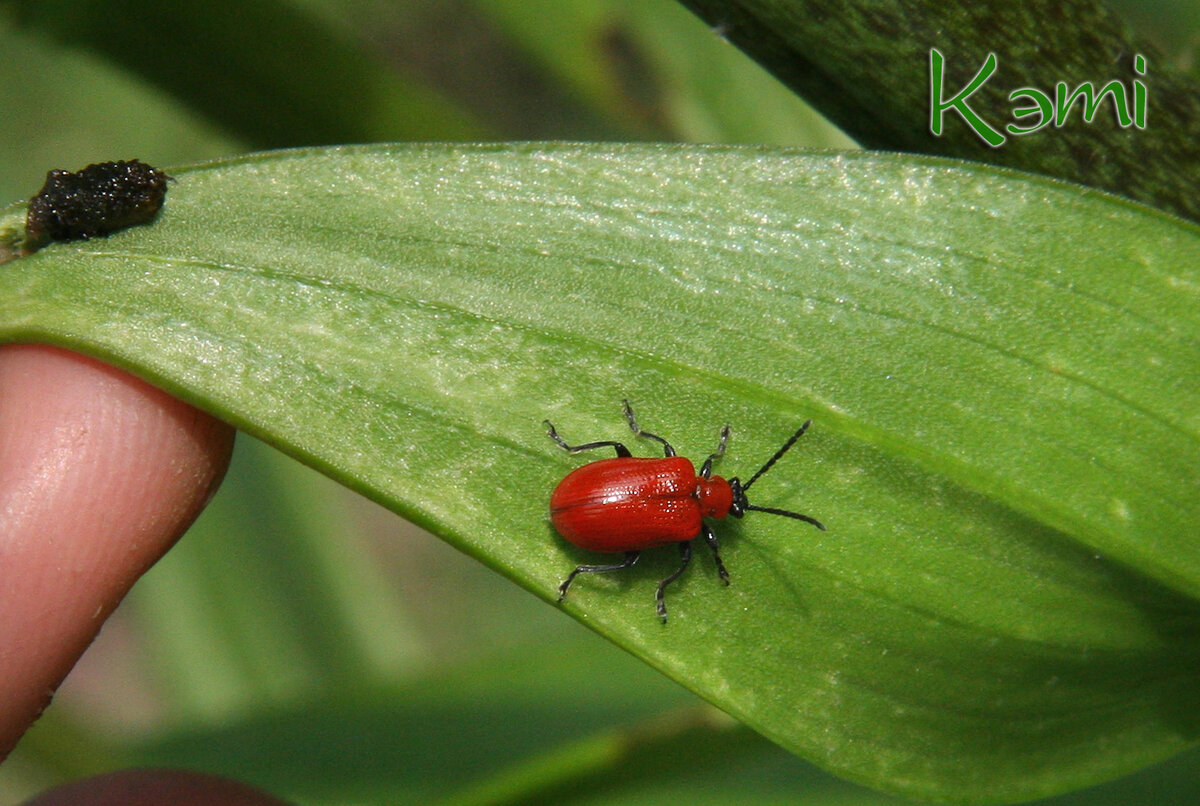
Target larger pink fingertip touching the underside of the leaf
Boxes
[0,344,234,758]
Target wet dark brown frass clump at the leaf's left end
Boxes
[25,160,170,245]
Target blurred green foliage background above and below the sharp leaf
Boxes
[0,0,1200,805]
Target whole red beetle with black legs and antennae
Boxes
[546,401,824,621]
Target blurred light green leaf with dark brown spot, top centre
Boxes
[472,0,853,148]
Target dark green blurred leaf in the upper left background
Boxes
[12,0,490,148]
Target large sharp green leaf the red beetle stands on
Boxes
[0,144,1200,802]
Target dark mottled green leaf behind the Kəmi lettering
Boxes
[680,0,1200,218]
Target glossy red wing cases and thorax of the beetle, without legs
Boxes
[550,457,733,552]
